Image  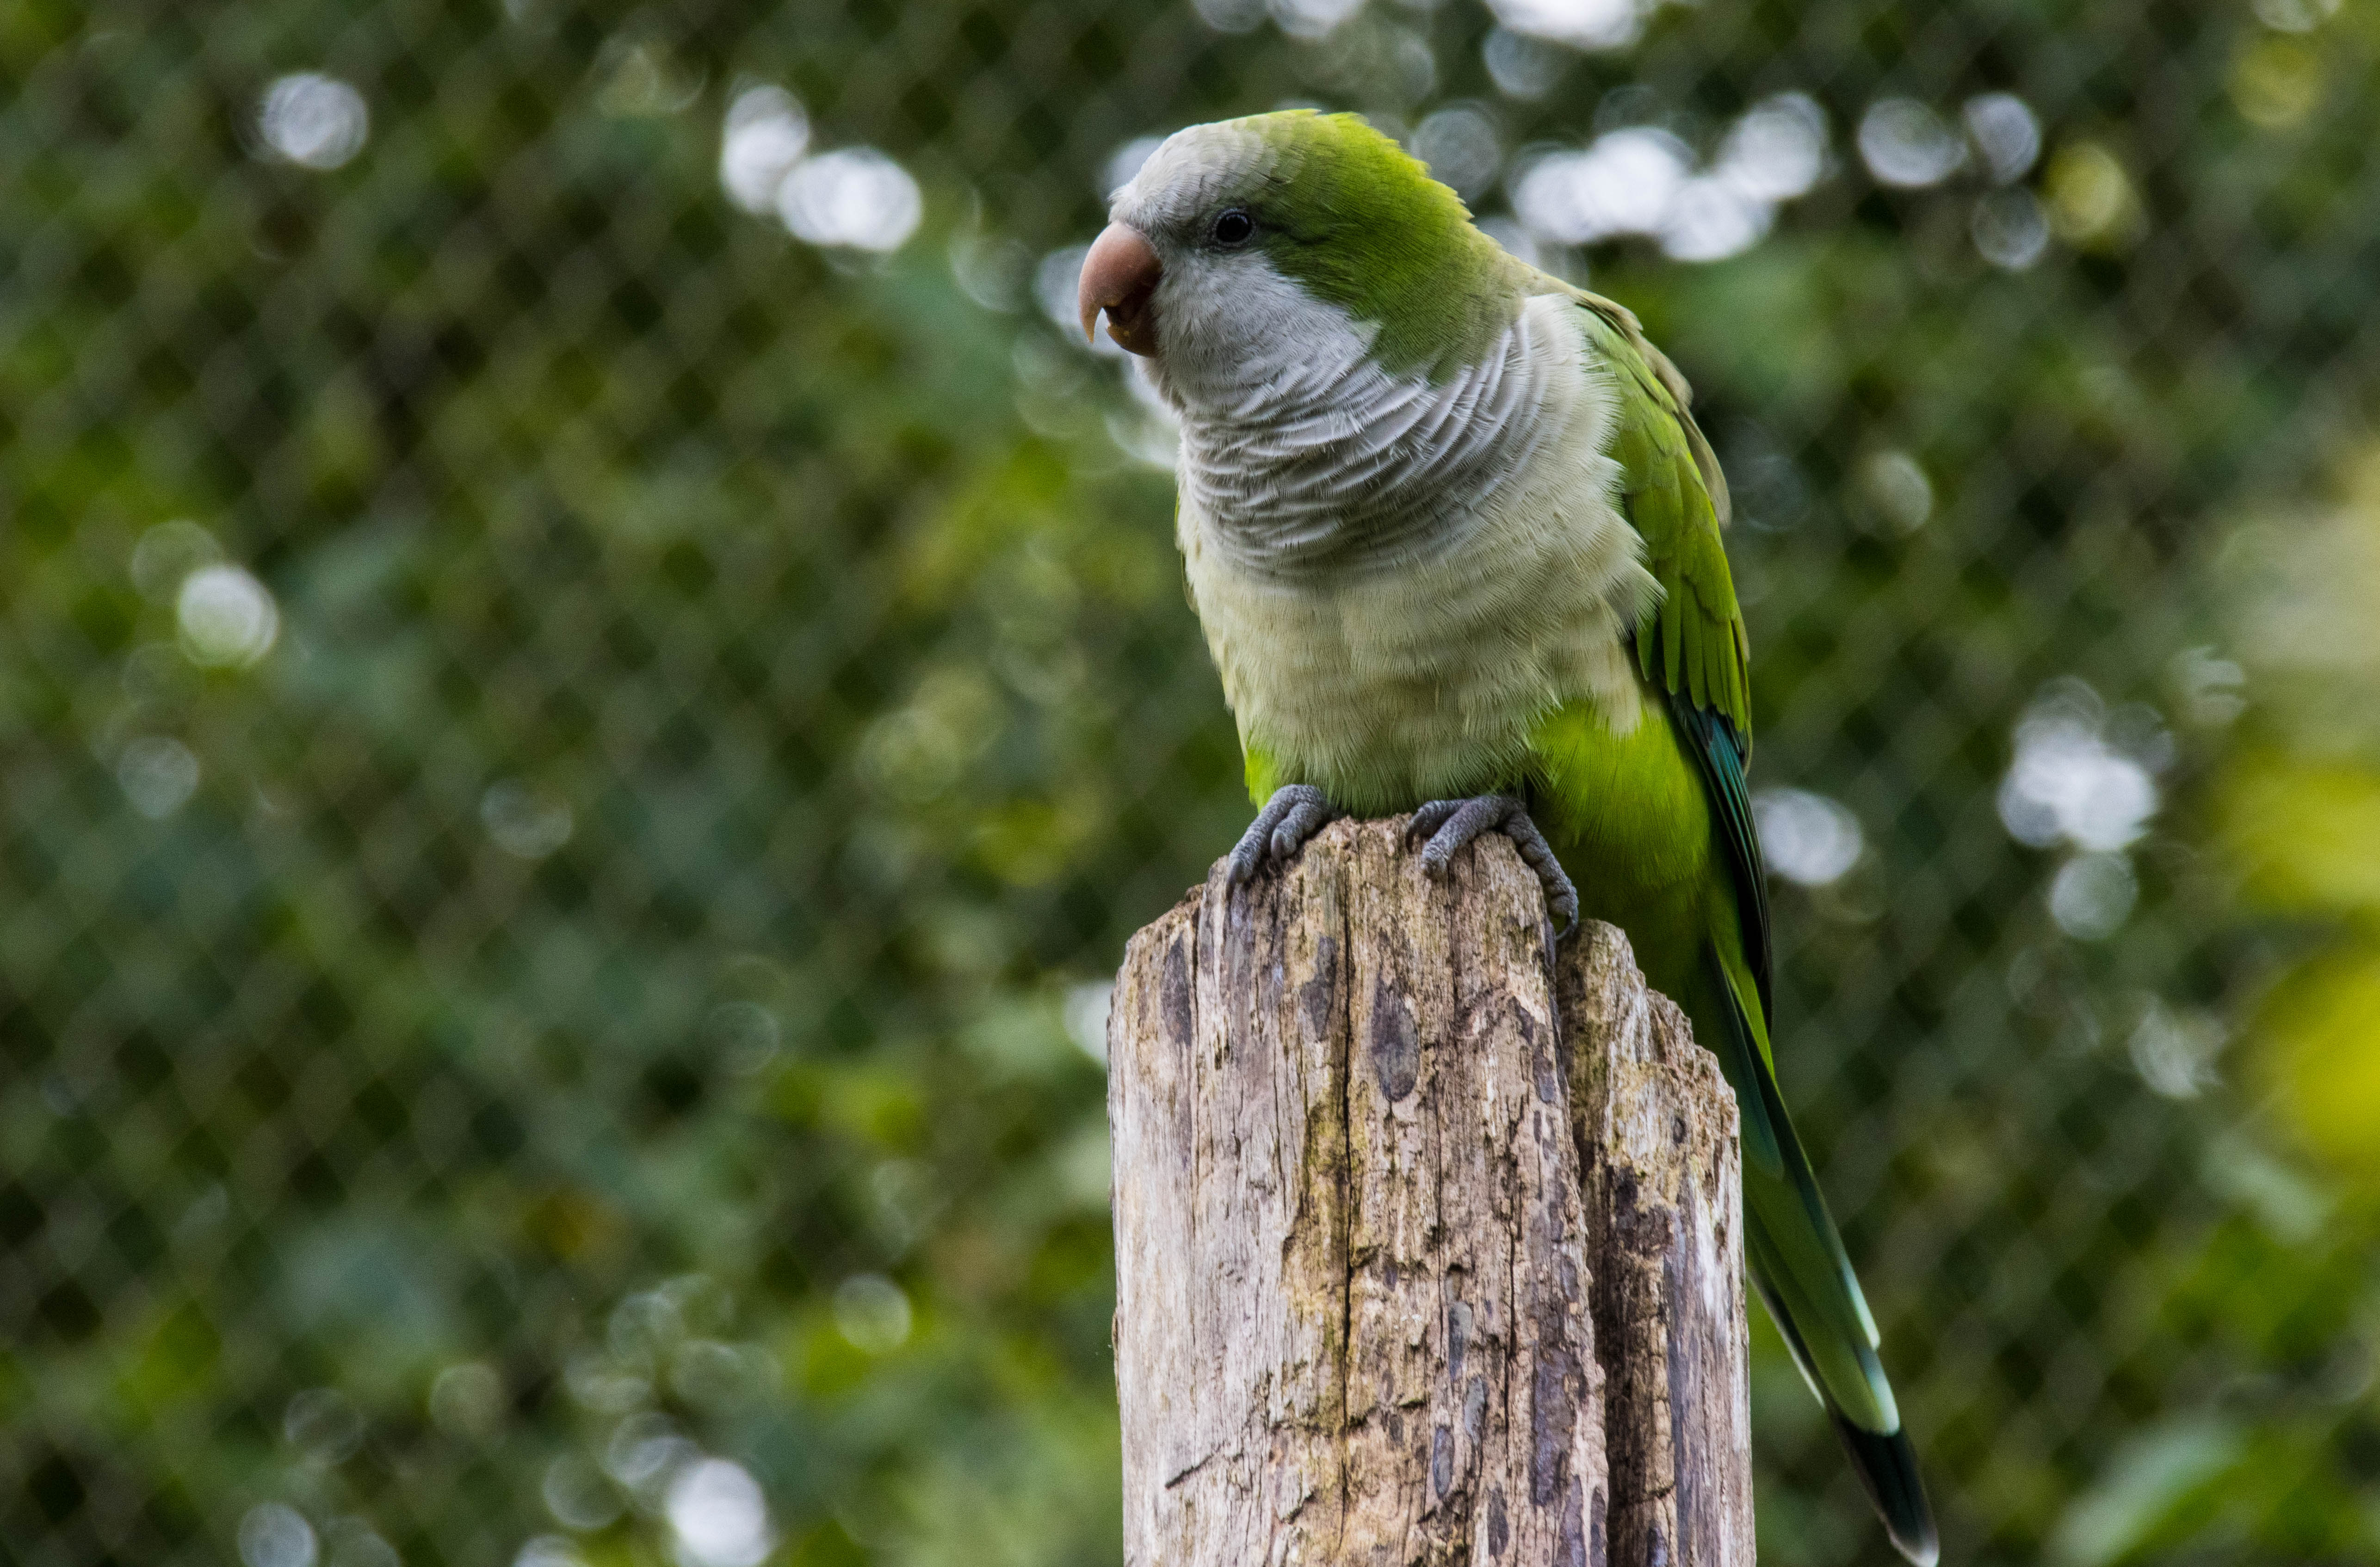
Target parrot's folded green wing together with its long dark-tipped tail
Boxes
[1578,292,1937,1562]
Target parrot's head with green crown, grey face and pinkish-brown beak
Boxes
[1078,109,1528,388]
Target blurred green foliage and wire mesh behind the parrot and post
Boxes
[0,0,2380,1567]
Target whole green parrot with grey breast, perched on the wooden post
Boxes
[1081,109,1937,1565]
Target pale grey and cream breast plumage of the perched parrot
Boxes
[1159,286,1659,813]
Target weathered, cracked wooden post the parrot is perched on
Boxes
[1109,823,1752,1567]
